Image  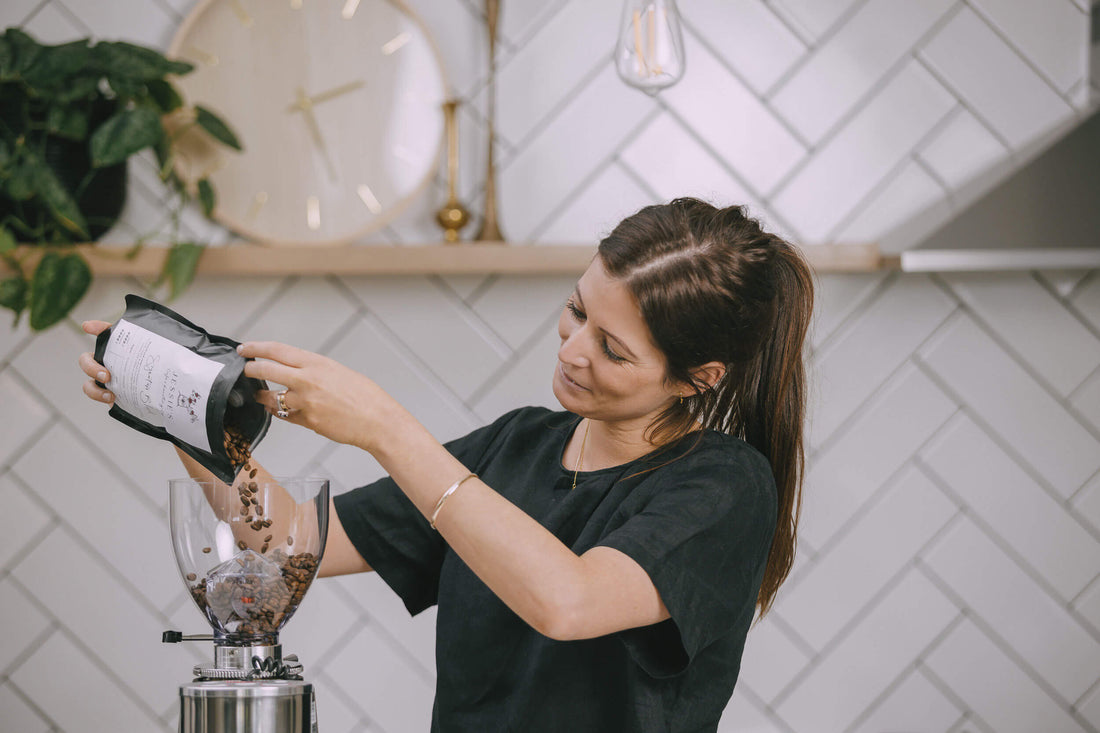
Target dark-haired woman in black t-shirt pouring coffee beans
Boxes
[81,198,813,733]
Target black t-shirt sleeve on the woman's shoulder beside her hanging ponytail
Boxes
[598,447,777,677]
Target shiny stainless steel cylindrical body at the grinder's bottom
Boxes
[179,679,317,733]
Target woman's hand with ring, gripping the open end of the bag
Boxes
[237,341,397,451]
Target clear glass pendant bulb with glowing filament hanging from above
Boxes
[615,0,684,95]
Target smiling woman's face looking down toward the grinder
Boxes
[553,256,678,428]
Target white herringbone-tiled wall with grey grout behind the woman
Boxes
[0,0,1100,733]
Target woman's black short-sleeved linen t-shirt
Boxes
[336,407,777,733]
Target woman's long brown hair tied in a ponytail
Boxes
[598,198,814,616]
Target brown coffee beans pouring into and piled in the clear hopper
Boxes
[187,427,318,641]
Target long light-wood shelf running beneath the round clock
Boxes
[0,241,897,277]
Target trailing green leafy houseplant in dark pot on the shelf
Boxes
[0,28,241,330]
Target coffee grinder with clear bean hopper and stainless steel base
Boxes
[163,471,329,733]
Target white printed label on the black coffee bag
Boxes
[103,319,226,452]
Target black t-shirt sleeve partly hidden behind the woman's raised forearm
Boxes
[333,411,528,615]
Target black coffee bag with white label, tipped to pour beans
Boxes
[96,295,271,483]
